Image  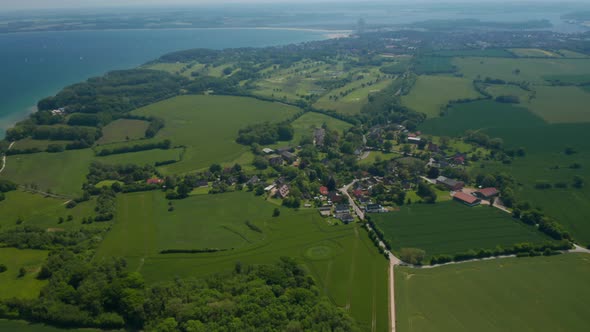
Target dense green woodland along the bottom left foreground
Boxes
[0,251,358,331]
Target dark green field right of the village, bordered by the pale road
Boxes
[371,201,550,257]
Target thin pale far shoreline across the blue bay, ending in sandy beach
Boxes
[0,27,354,39]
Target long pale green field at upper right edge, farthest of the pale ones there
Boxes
[453,58,590,84]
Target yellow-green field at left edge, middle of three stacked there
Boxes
[0,191,102,230]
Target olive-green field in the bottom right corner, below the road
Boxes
[395,254,590,332]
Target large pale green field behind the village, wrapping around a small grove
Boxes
[134,96,300,173]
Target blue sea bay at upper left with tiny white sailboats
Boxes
[0,29,326,137]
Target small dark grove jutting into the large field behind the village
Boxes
[236,122,295,145]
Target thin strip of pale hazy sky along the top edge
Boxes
[0,0,576,13]
